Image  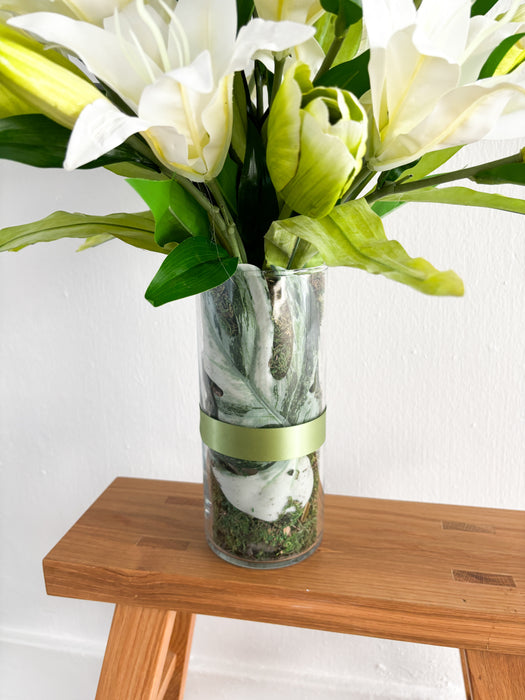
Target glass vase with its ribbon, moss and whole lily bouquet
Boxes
[0,0,525,567]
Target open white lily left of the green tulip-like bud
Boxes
[10,0,315,181]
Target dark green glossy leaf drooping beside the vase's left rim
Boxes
[146,237,238,306]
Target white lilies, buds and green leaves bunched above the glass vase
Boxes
[0,0,525,305]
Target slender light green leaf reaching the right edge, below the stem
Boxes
[372,187,525,214]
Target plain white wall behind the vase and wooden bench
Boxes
[0,139,525,700]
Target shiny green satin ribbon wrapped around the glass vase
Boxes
[200,410,326,462]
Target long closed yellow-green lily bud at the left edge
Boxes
[0,24,102,128]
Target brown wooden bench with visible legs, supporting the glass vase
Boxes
[44,478,525,700]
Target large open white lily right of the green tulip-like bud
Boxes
[362,0,525,170]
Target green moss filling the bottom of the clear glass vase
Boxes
[209,453,320,561]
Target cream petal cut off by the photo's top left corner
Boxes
[0,0,132,24]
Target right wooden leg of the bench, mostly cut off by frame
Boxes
[460,649,525,700]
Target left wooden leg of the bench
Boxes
[96,605,195,700]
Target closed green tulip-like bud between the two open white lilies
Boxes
[266,64,367,218]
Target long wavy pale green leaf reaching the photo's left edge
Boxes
[0,211,167,254]
